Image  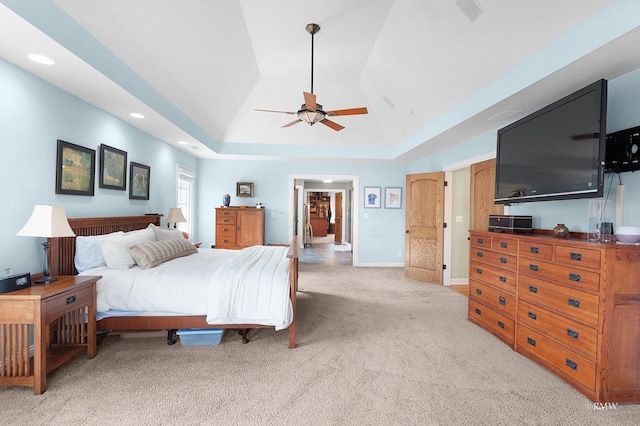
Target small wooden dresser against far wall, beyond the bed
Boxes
[216,207,264,249]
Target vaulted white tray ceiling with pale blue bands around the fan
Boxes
[0,0,640,162]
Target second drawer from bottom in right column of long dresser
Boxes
[518,300,598,359]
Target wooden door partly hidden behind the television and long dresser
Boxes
[469,158,504,231]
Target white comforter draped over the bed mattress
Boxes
[81,246,293,330]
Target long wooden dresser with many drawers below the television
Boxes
[468,231,640,403]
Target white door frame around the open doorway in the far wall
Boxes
[288,173,360,266]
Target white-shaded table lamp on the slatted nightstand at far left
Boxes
[16,205,76,284]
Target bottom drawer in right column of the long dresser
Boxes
[516,326,596,392]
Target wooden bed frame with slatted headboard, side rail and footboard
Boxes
[49,214,298,348]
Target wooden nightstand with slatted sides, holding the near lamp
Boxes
[0,275,102,395]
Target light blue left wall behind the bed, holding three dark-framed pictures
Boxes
[0,60,196,274]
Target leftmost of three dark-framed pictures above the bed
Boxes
[56,139,96,196]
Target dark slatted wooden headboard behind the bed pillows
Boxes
[49,214,162,276]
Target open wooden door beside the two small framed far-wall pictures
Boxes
[404,172,444,285]
